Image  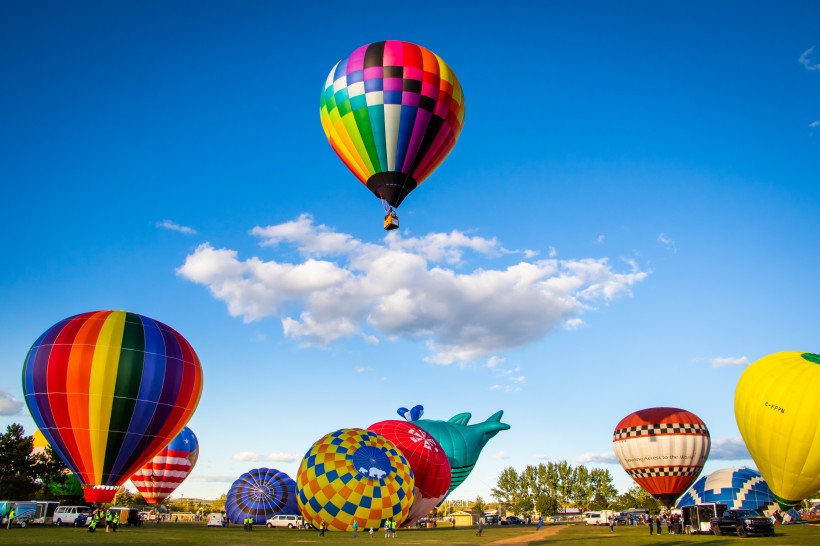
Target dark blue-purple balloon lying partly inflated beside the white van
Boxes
[225,468,299,525]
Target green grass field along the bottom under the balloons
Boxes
[0,523,820,546]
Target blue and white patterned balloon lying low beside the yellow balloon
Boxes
[675,468,774,511]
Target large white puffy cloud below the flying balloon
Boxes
[177,215,648,364]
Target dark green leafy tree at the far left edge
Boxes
[0,423,41,499]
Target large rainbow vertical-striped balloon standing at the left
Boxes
[23,311,202,502]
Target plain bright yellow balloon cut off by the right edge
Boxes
[735,352,820,510]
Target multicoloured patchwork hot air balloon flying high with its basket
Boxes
[319,40,464,229]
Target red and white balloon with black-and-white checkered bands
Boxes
[612,408,711,507]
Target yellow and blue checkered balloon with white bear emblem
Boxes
[296,428,415,531]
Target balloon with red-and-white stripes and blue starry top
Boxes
[131,427,199,504]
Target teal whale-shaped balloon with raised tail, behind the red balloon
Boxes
[411,411,510,495]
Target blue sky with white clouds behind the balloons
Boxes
[0,0,820,499]
